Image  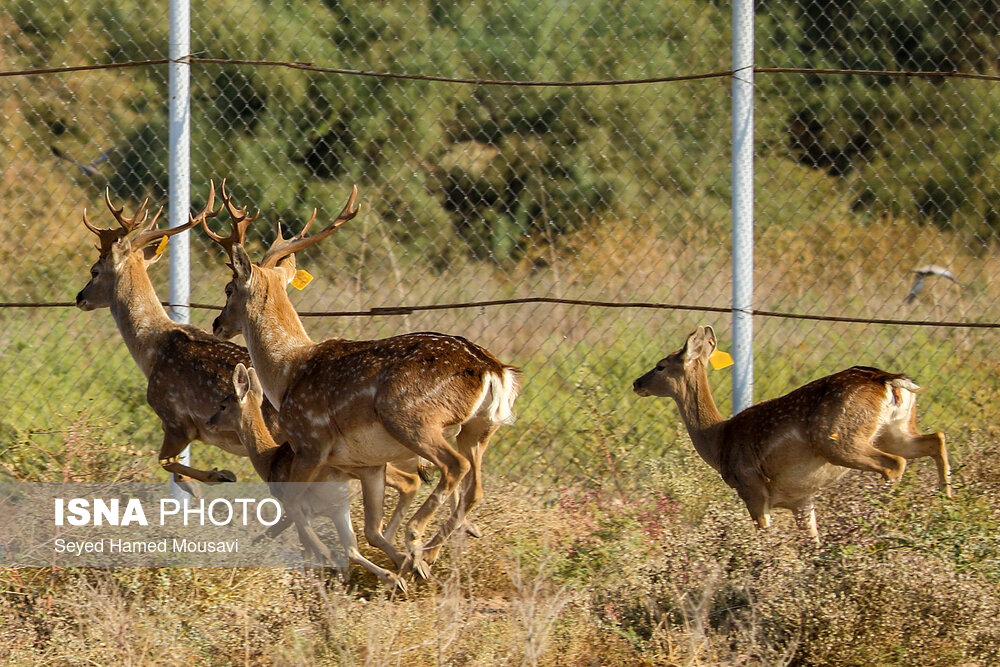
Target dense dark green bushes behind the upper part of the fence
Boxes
[8,0,1000,265]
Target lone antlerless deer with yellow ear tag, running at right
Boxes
[632,326,951,543]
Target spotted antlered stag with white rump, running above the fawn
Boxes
[203,182,519,576]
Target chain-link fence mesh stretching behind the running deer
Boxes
[0,0,1000,490]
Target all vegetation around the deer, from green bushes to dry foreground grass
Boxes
[0,0,1000,665]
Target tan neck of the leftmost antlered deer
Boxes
[111,263,177,378]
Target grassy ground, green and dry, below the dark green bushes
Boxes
[0,168,1000,666]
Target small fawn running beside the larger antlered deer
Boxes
[209,364,406,592]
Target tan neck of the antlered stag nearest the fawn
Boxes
[243,285,314,409]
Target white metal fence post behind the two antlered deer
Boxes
[168,0,191,498]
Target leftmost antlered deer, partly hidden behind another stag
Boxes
[76,186,277,492]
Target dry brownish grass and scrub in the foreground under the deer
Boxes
[0,430,1000,666]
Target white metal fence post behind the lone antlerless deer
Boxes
[732,0,754,413]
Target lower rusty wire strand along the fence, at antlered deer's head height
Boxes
[0,296,1000,329]
